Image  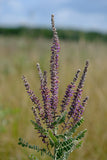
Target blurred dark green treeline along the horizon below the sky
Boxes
[0,27,107,42]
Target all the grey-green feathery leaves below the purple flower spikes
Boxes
[18,112,87,160]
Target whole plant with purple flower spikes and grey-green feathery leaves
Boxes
[18,15,88,160]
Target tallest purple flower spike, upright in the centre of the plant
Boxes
[50,15,60,119]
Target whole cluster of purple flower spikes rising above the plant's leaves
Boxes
[22,15,89,144]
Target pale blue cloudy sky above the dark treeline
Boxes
[0,0,107,33]
